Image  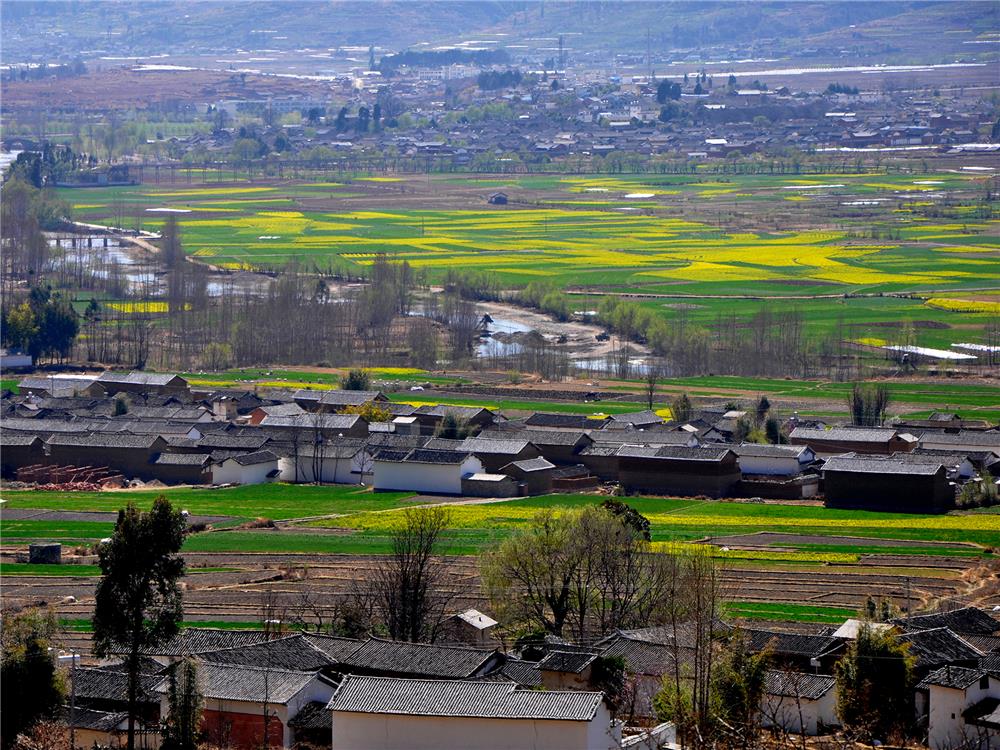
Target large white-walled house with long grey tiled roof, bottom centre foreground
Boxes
[329,675,621,750]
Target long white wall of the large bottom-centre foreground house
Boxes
[333,709,620,750]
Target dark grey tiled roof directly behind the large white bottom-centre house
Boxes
[340,638,497,679]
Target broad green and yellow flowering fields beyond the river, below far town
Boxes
[56,171,1000,347]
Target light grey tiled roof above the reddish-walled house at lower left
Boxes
[156,662,322,705]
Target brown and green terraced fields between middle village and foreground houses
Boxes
[0,494,1000,645]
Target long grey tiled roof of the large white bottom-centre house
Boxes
[329,675,603,721]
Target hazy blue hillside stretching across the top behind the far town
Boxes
[2,0,1000,61]
